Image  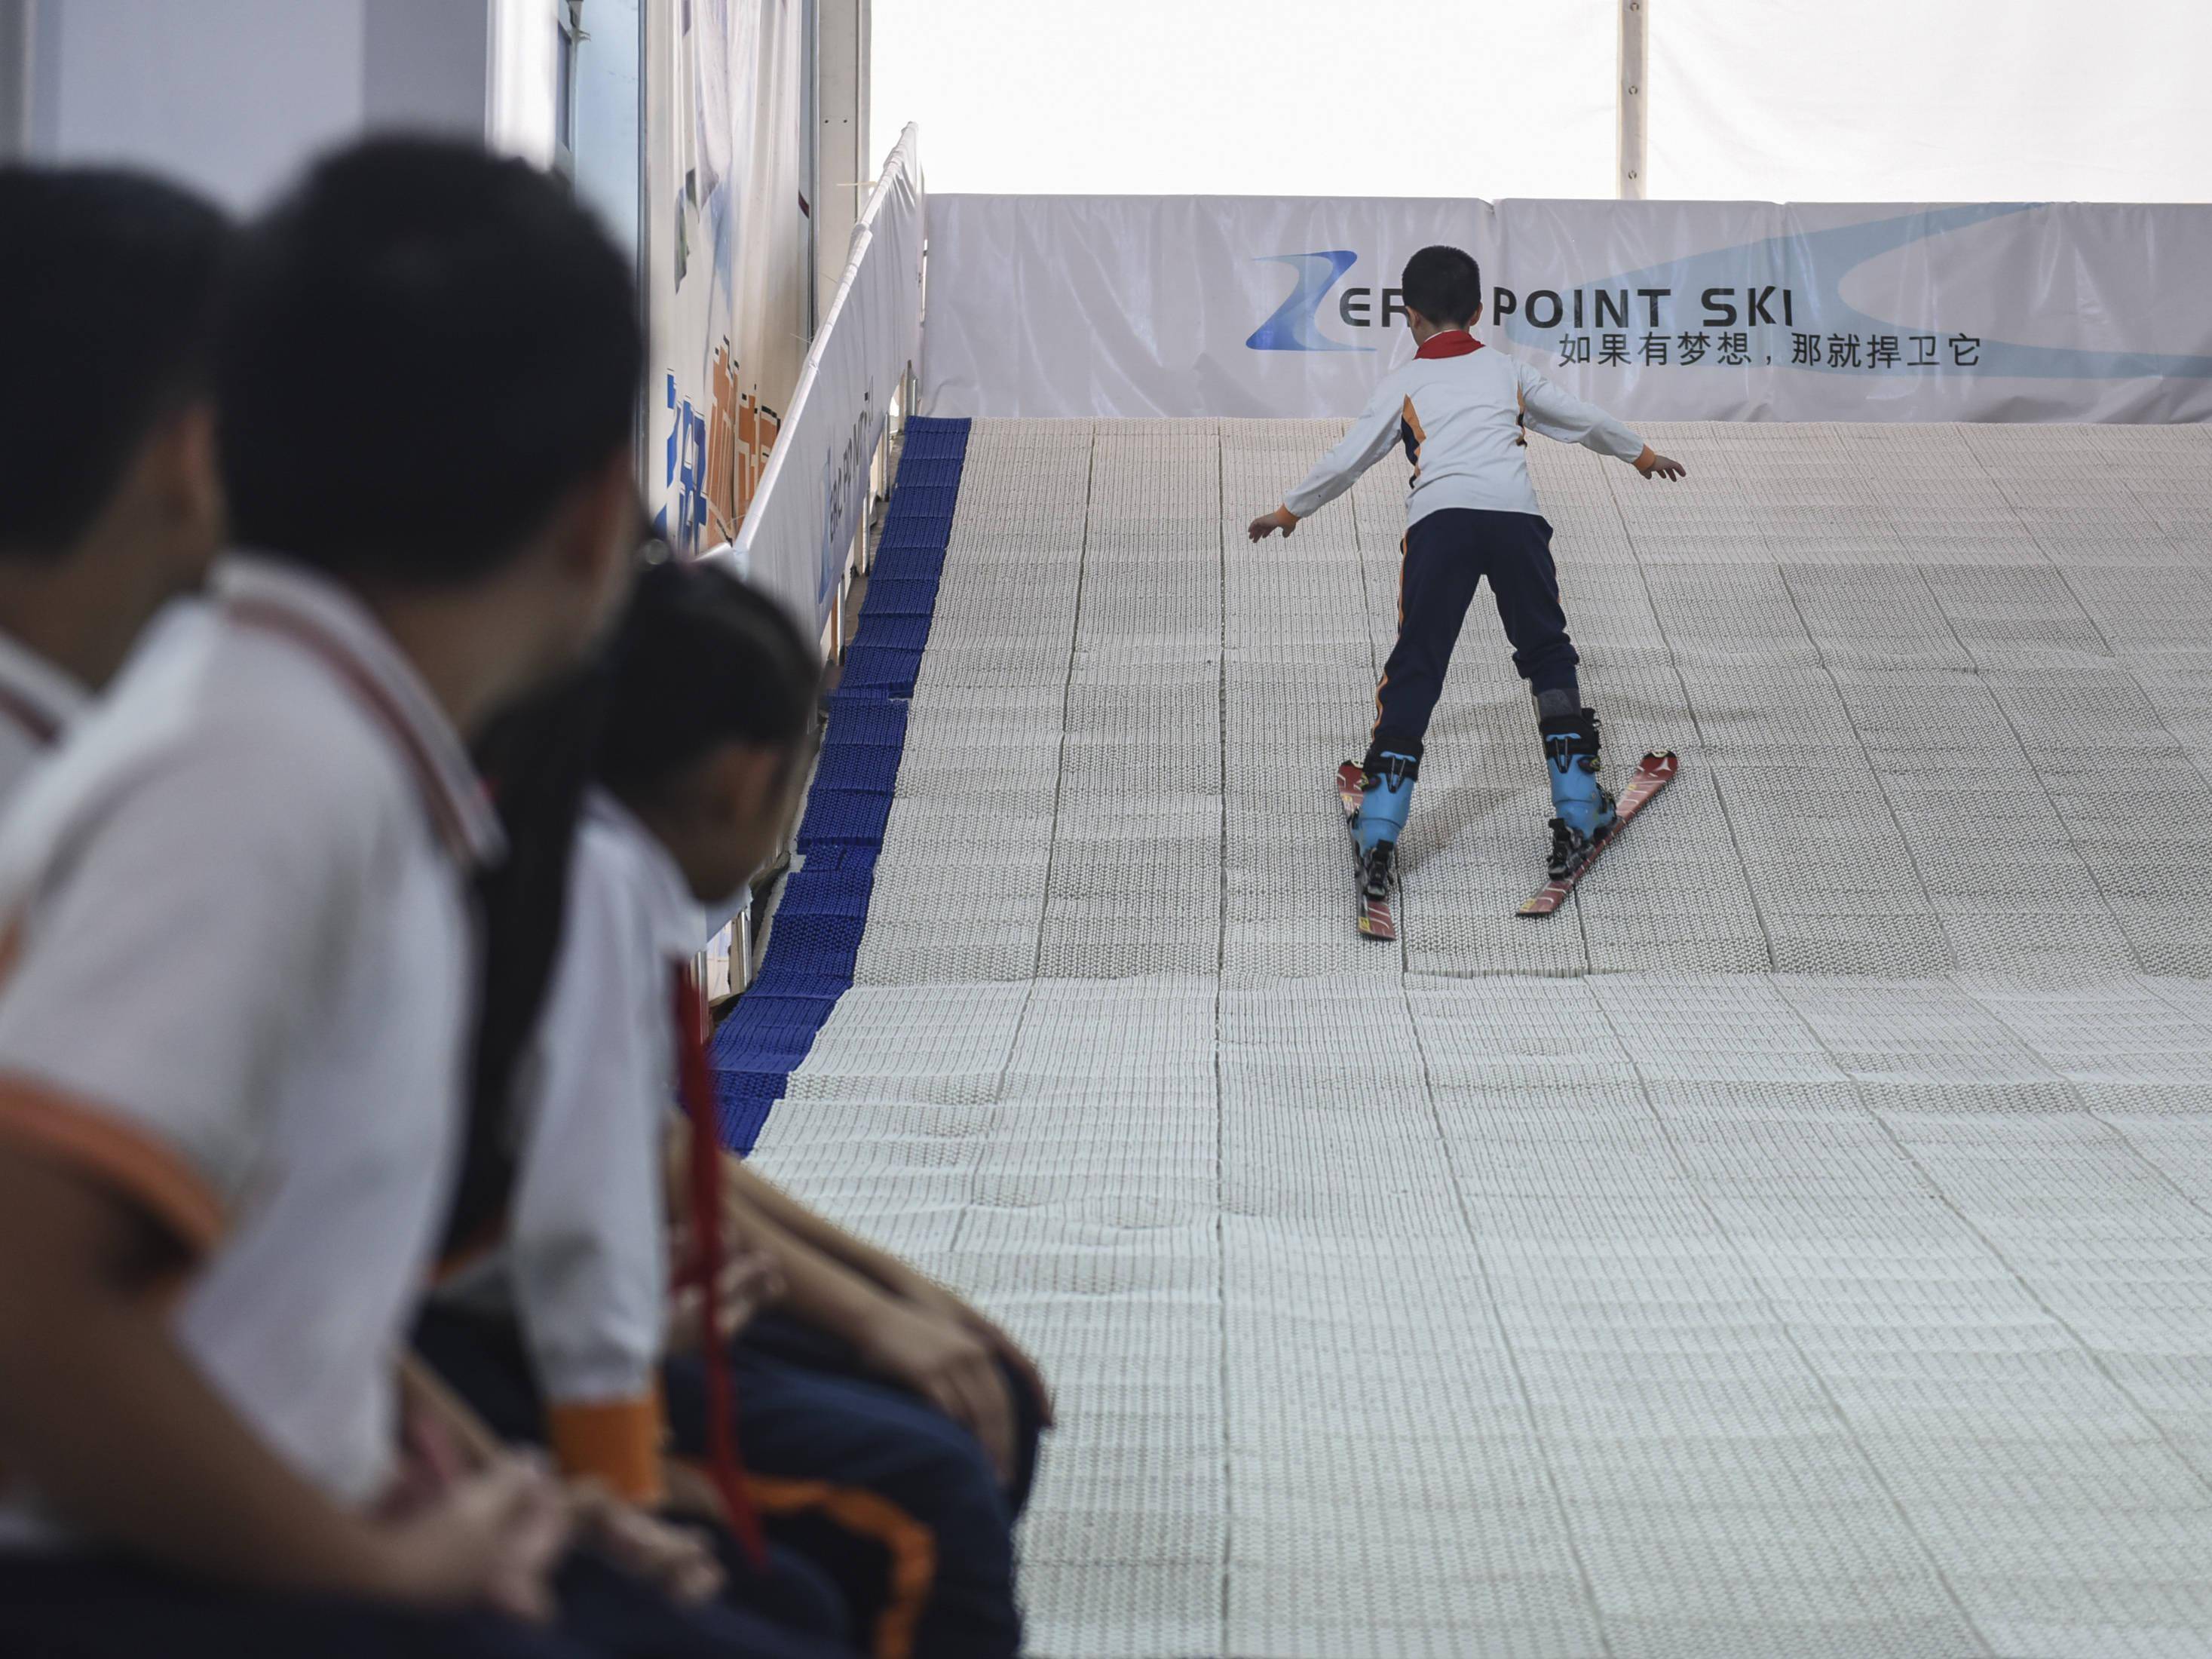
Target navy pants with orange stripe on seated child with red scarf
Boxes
[663,1316,1042,1659]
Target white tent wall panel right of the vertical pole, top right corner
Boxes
[1646,0,2212,201]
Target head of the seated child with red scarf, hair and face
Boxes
[599,562,821,903]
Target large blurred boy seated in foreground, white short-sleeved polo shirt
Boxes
[0,140,819,1659]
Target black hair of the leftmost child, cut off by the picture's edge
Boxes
[0,166,232,557]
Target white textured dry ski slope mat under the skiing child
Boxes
[763,420,2212,1659]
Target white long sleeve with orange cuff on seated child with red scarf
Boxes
[449,790,708,1500]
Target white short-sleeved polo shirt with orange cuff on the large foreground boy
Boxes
[0,555,500,1546]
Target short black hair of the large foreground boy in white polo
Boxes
[217,137,646,586]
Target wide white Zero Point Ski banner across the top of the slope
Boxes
[922,195,2212,420]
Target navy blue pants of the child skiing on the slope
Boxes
[1374,507,1582,759]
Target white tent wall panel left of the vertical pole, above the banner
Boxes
[874,0,1619,195]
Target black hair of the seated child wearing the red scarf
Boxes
[599,560,821,799]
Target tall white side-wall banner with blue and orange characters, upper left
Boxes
[646,0,814,553]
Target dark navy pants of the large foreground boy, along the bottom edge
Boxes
[0,1555,845,1659]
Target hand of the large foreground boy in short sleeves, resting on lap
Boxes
[383,1458,571,1624]
